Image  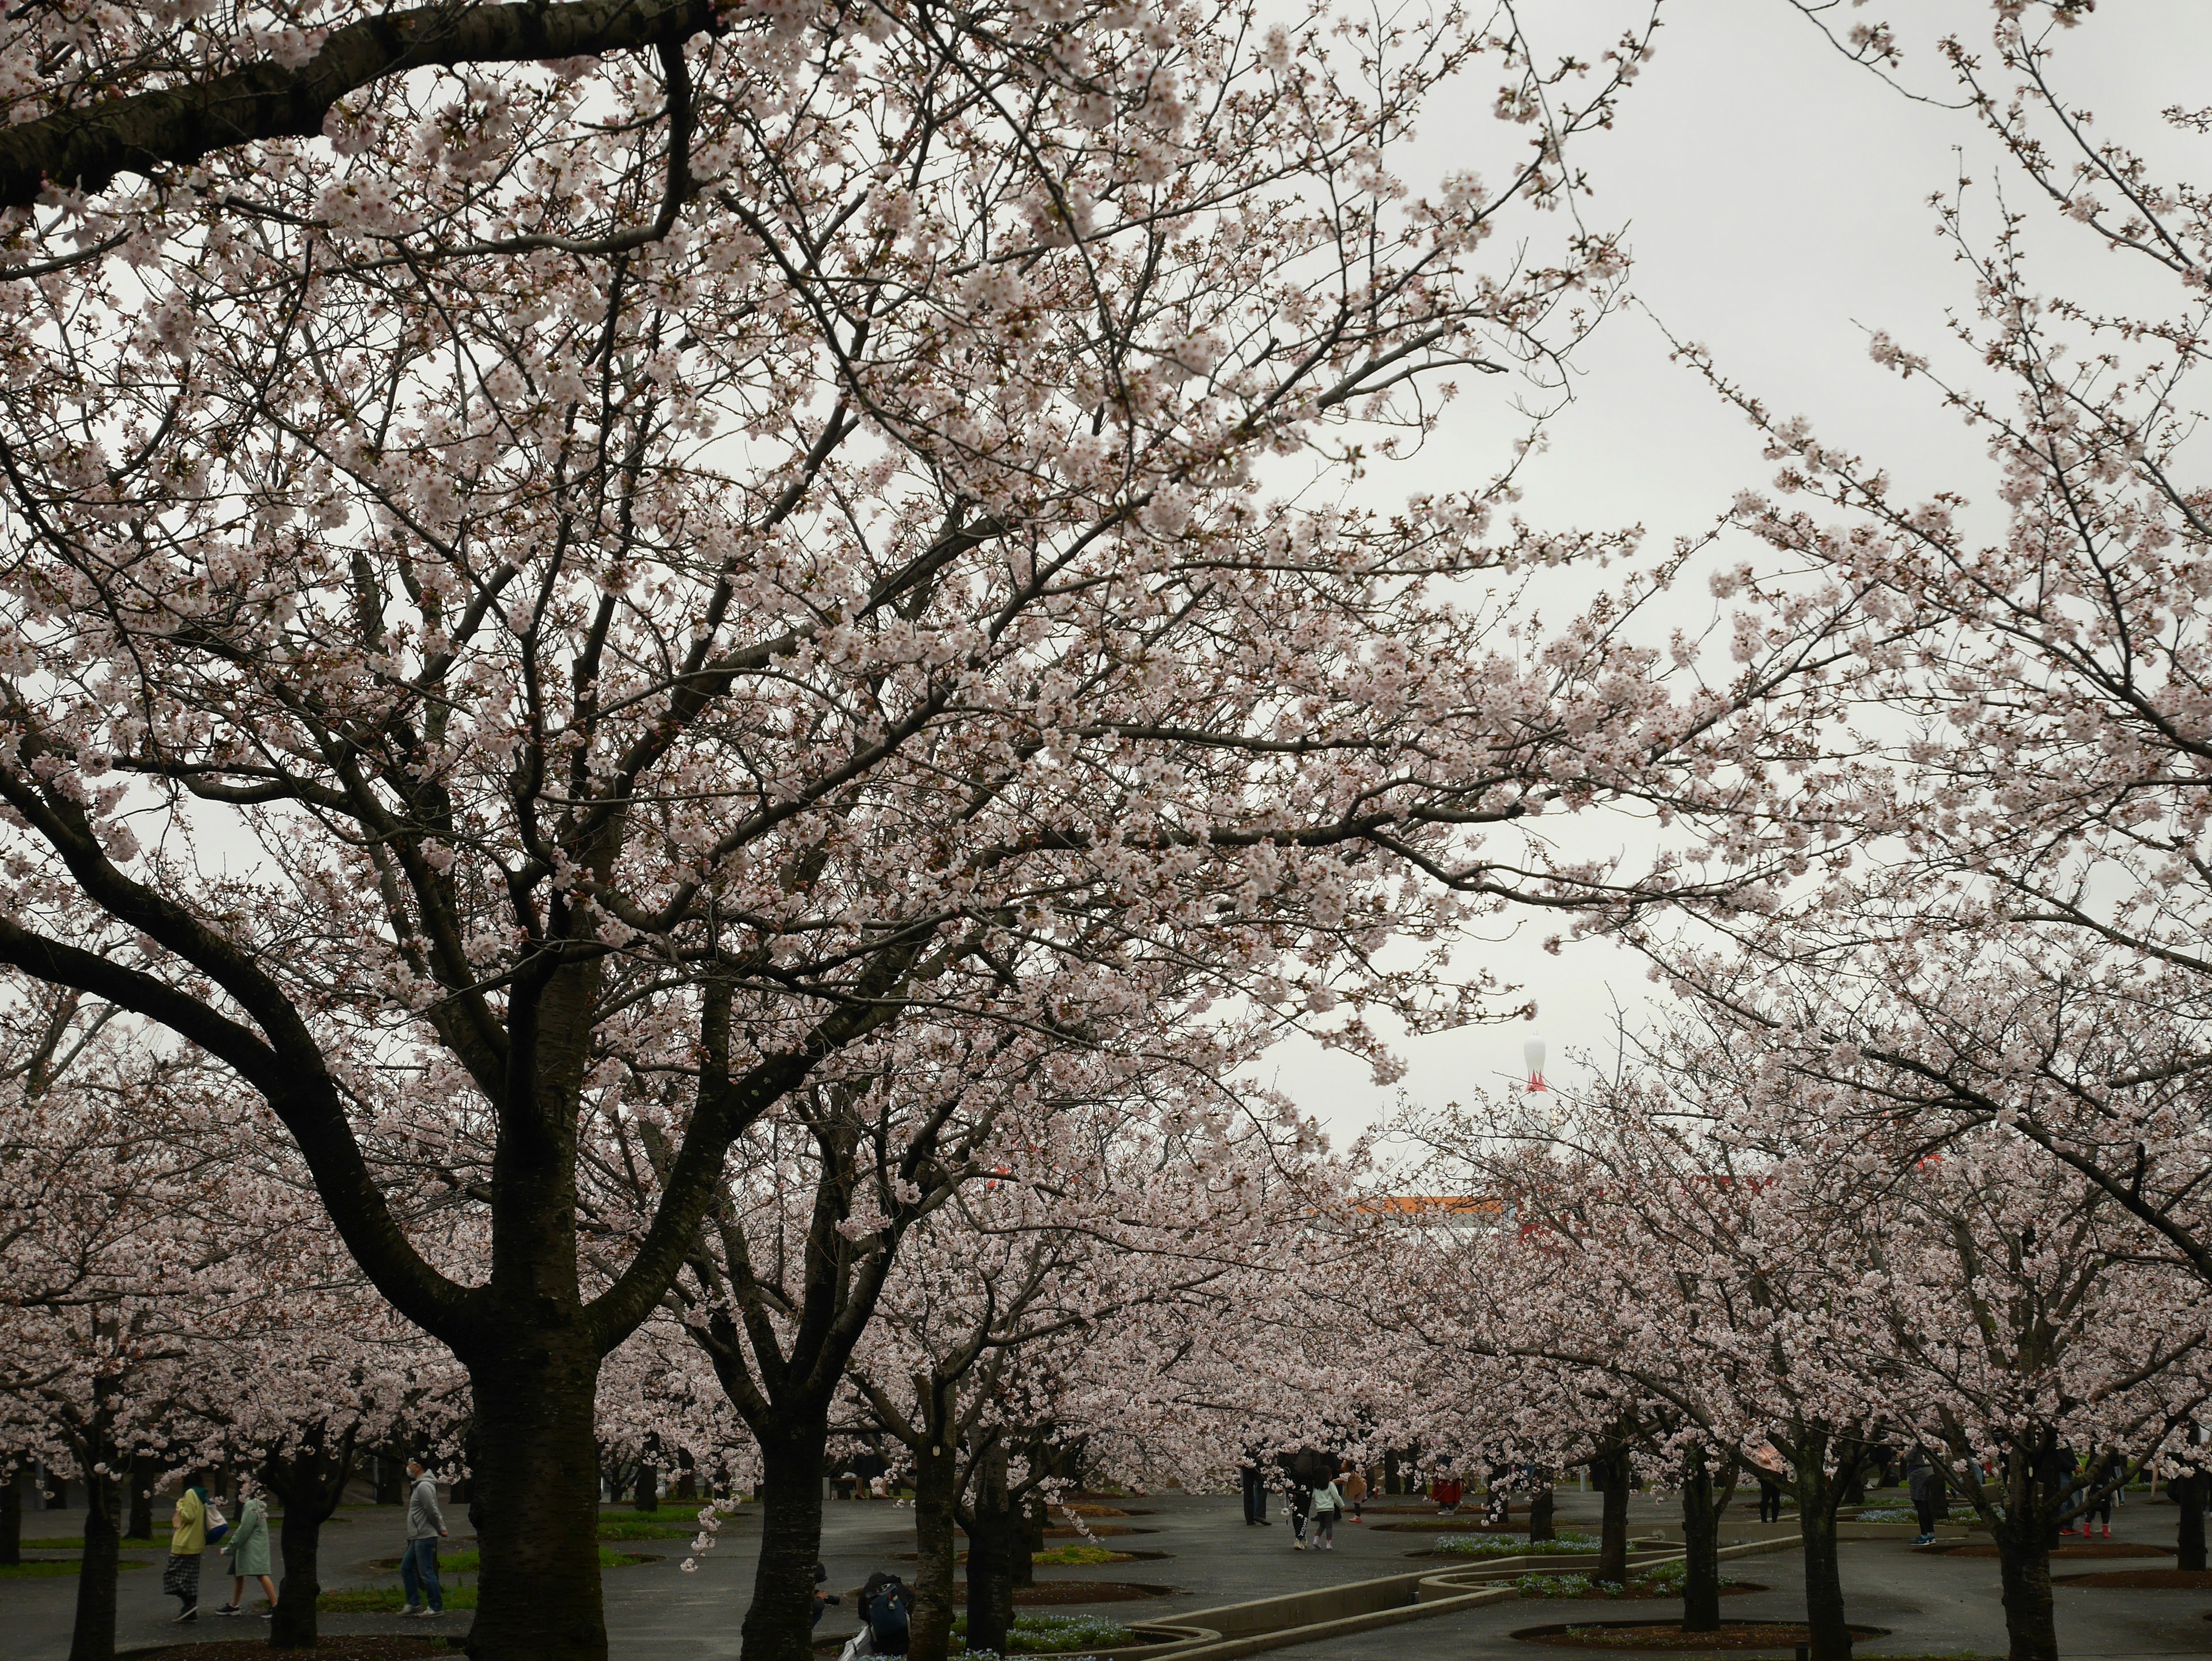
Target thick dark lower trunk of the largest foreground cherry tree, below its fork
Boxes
[467,1335,606,1661]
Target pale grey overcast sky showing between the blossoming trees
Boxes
[1263,0,2212,1134]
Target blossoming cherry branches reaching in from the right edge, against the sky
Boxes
[1659,2,2212,1278]
